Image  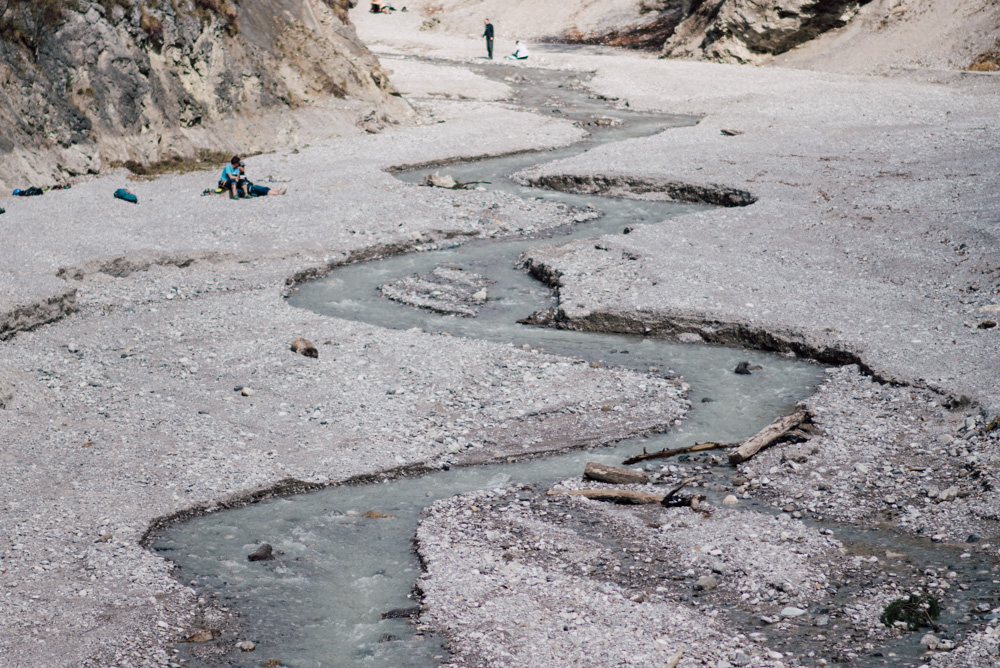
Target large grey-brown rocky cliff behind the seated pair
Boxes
[0,0,407,189]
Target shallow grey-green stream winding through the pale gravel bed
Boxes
[153,60,990,668]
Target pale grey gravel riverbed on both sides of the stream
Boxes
[0,5,1000,668]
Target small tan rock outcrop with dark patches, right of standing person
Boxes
[663,0,870,64]
